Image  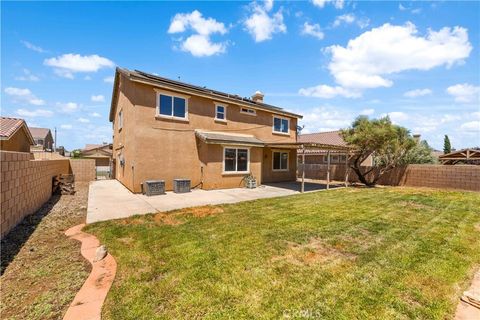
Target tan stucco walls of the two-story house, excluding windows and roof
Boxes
[113,74,297,192]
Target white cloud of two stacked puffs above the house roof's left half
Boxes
[168,10,228,57]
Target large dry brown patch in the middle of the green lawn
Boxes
[272,238,356,266]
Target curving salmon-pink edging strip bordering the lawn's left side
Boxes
[63,223,117,320]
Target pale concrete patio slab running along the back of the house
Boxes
[87,180,338,223]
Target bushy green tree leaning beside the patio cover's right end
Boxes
[342,116,416,187]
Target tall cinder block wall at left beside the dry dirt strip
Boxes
[0,151,70,238]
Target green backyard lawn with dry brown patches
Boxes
[86,188,480,319]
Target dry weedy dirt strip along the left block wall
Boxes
[0,183,90,319]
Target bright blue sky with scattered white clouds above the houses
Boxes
[1,0,480,149]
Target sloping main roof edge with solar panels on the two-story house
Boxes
[109,67,302,121]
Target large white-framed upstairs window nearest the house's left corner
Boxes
[156,90,189,120]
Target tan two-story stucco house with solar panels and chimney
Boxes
[110,68,301,192]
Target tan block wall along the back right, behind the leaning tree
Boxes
[298,164,480,191]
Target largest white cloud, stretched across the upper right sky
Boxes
[304,22,472,97]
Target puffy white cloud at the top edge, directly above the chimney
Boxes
[244,1,287,42]
